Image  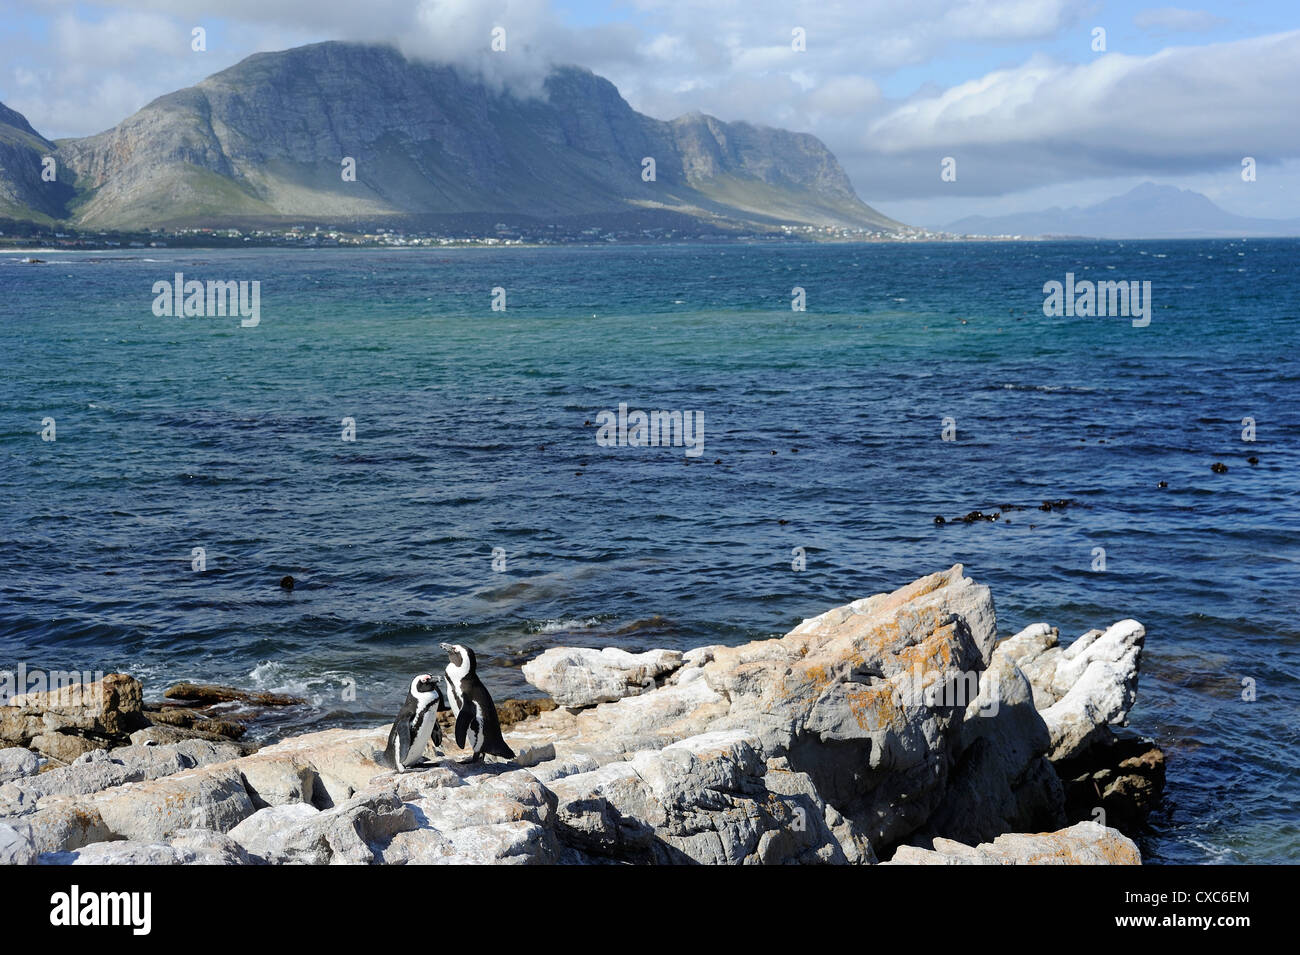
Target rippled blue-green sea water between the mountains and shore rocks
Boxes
[0,240,1300,863]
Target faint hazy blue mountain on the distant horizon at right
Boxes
[948,182,1300,239]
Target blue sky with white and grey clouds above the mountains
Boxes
[0,0,1300,226]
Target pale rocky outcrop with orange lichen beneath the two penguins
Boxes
[0,565,1159,864]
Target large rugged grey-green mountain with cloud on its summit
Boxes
[0,42,904,229]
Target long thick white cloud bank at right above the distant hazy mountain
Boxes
[849,31,1300,197]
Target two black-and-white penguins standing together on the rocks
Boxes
[384,643,515,773]
